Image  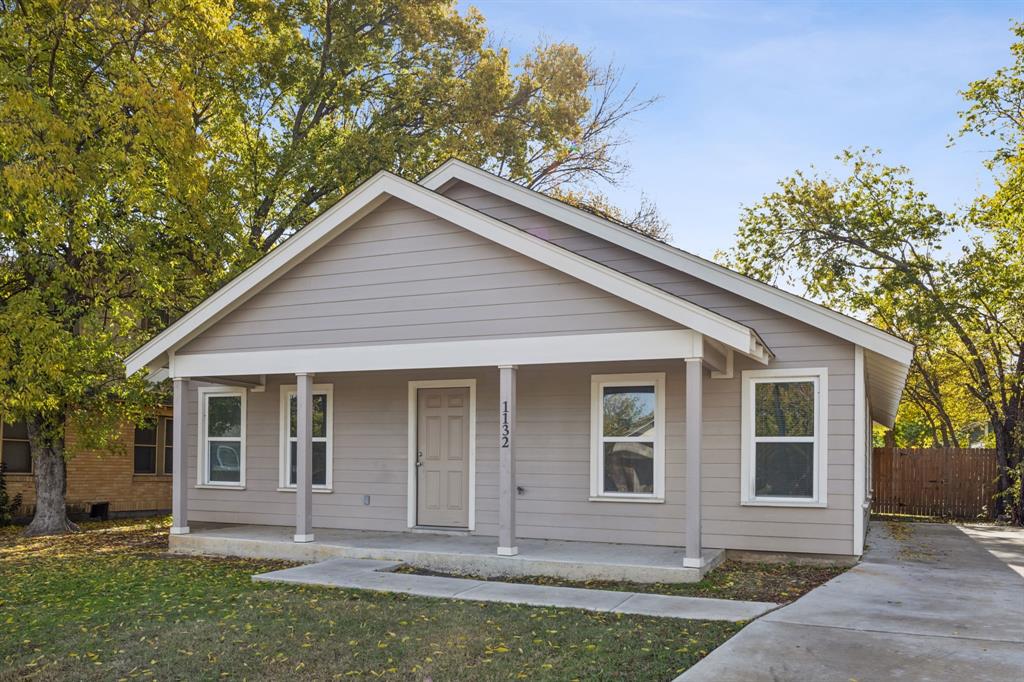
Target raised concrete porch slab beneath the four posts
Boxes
[170,523,724,583]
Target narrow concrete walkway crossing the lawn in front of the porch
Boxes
[253,559,777,621]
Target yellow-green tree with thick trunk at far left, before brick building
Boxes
[0,1,238,535]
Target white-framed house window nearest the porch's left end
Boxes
[199,387,246,487]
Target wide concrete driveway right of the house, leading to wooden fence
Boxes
[679,522,1024,682]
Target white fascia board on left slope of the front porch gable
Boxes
[125,171,393,376]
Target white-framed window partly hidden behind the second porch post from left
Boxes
[280,384,334,489]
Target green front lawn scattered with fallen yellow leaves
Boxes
[0,520,740,681]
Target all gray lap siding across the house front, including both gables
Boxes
[178,179,854,554]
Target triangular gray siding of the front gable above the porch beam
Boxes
[178,200,679,354]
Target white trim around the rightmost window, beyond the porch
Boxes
[739,368,828,508]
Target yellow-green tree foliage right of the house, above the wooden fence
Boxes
[727,25,1024,522]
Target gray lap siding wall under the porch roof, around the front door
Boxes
[186,361,686,546]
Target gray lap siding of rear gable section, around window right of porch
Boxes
[445,182,854,554]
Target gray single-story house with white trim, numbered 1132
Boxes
[126,161,912,569]
